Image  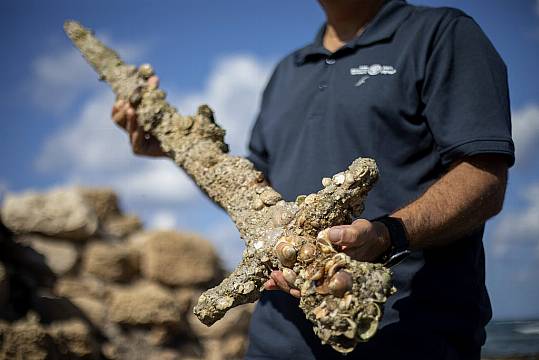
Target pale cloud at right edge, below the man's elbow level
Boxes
[493,183,539,257]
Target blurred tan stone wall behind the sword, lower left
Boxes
[0,188,252,360]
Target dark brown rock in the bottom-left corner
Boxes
[0,320,59,360]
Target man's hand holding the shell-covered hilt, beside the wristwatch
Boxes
[264,219,391,297]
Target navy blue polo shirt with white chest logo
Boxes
[248,0,514,359]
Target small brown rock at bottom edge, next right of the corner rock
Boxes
[48,320,99,360]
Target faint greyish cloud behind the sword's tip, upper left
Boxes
[25,35,146,112]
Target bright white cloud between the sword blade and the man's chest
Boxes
[173,55,272,155]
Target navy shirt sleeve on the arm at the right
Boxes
[422,16,515,166]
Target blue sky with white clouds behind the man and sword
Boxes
[0,0,539,319]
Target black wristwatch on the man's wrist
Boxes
[371,215,411,267]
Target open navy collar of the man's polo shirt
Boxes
[296,0,412,65]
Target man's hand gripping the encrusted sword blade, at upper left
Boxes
[112,76,165,157]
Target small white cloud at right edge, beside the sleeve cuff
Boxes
[512,104,539,164]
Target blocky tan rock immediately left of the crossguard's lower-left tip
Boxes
[109,282,183,327]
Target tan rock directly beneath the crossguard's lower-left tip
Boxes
[188,304,254,338]
